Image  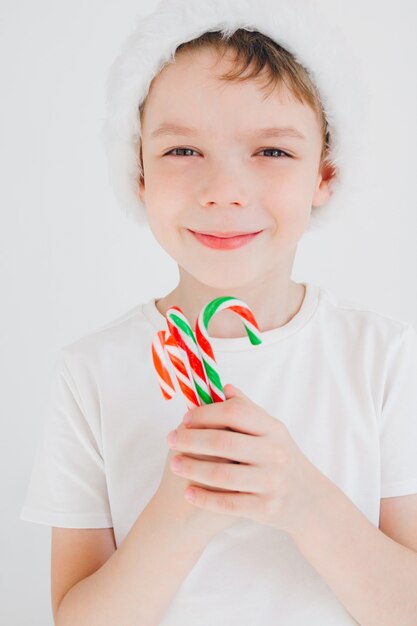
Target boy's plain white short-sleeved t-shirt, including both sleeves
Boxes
[20,283,417,626]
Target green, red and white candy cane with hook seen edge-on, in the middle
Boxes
[165,306,213,404]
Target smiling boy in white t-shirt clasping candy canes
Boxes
[23,2,417,626]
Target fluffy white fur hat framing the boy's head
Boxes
[102,0,367,229]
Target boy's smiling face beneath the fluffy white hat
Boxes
[139,49,332,290]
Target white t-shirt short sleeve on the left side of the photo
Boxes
[20,348,113,528]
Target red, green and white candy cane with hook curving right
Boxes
[195,296,262,402]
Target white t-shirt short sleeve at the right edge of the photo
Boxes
[380,323,417,498]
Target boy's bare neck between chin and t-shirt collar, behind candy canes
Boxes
[155,278,306,338]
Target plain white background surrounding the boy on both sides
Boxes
[0,0,417,626]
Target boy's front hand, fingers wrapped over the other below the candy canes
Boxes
[169,385,332,533]
